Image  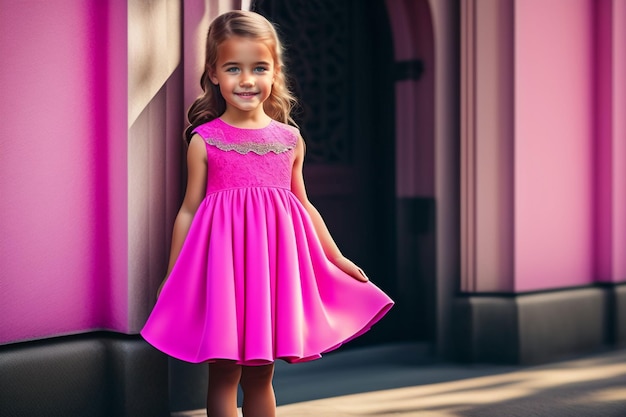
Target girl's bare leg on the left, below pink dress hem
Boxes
[207,361,241,417]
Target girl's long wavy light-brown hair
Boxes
[185,10,297,142]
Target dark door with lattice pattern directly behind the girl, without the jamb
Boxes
[252,0,407,346]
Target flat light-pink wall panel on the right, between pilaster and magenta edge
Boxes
[514,0,594,291]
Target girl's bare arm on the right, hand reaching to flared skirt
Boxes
[291,138,368,282]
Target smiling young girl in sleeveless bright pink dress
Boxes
[141,11,393,417]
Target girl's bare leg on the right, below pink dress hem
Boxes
[241,364,276,417]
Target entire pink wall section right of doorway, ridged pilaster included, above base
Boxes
[461,0,626,293]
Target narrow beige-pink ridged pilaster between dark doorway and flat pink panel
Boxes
[461,0,514,292]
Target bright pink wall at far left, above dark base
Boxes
[0,0,127,343]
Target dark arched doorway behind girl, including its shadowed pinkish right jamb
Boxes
[251,0,436,346]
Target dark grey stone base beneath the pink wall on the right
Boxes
[453,285,626,364]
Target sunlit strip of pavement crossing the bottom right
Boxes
[278,351,626,417]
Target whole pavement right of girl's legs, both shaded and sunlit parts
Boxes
[174,345,626,417]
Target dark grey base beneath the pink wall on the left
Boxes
[0,332,169,417]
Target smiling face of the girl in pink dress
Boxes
[211,37,276,117]
